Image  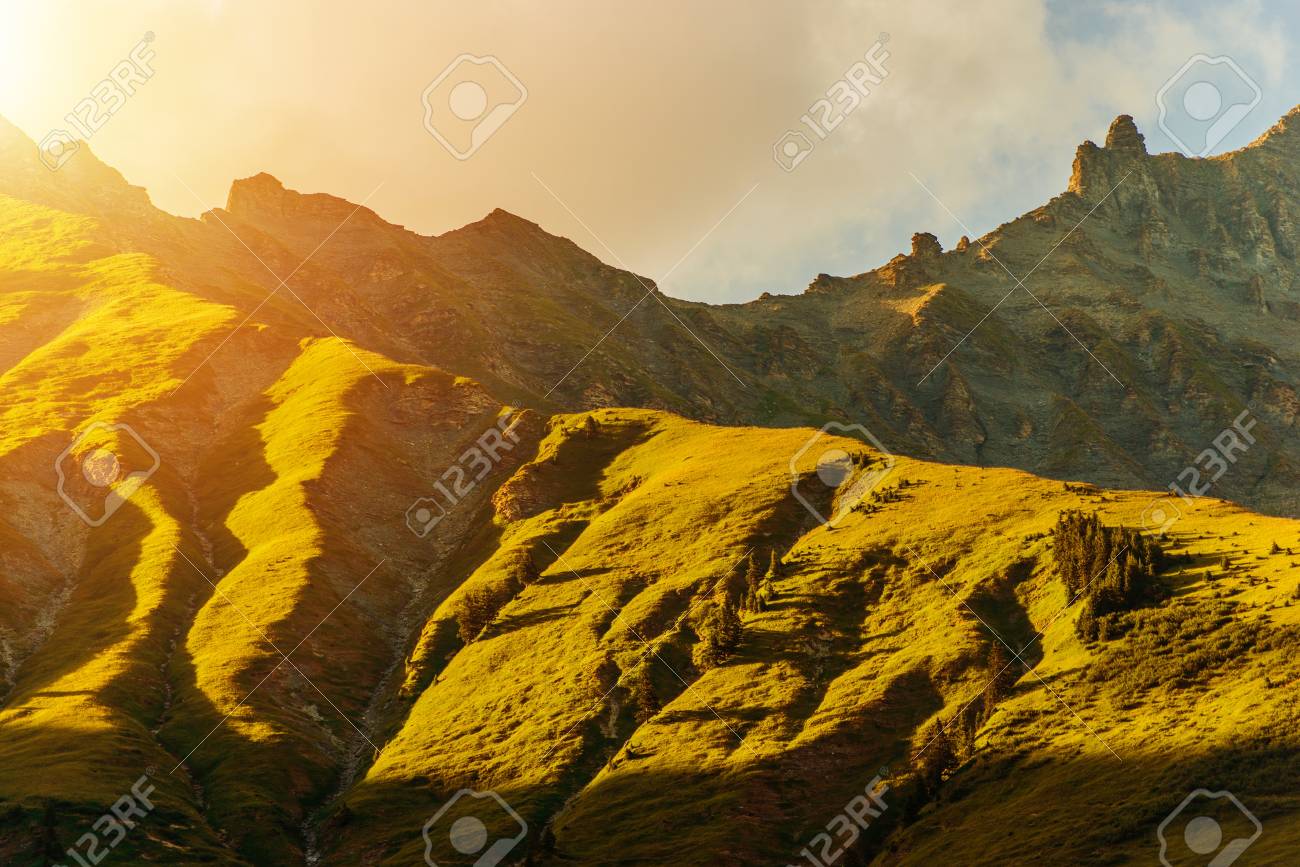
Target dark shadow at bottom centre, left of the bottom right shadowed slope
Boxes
[315,660,943,864]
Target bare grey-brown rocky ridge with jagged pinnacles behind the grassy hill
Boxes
[192,114,1300,513]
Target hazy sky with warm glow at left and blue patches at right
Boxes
[0,0,1300,303]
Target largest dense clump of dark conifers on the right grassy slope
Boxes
[1052,511,1166,641]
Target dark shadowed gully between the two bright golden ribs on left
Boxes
[146,358,345,863]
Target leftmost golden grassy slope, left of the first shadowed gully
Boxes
[0,188,258,863]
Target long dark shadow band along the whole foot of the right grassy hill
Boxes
[314,717,1300,867]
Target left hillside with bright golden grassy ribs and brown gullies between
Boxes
[0,162,533,863]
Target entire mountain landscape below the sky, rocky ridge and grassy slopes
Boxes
[0,114,1300,864]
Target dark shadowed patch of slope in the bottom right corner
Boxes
[875,741,1300,866]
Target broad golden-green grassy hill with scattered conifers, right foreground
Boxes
[328,409,1300,864]
